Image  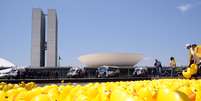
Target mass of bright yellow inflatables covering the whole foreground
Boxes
[0,79,201,101]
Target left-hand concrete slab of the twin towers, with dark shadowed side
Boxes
[31,8,45,67]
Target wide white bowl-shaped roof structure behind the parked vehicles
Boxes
[79,53,143,67]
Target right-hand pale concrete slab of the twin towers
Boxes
[47,9,57,67]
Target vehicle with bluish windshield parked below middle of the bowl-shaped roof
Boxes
[96,66,120,78]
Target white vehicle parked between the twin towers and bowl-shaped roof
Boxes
[67,67,86,78]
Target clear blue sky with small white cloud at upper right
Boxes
[0,0,201,65]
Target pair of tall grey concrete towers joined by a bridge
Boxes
[31,8,58,67]
